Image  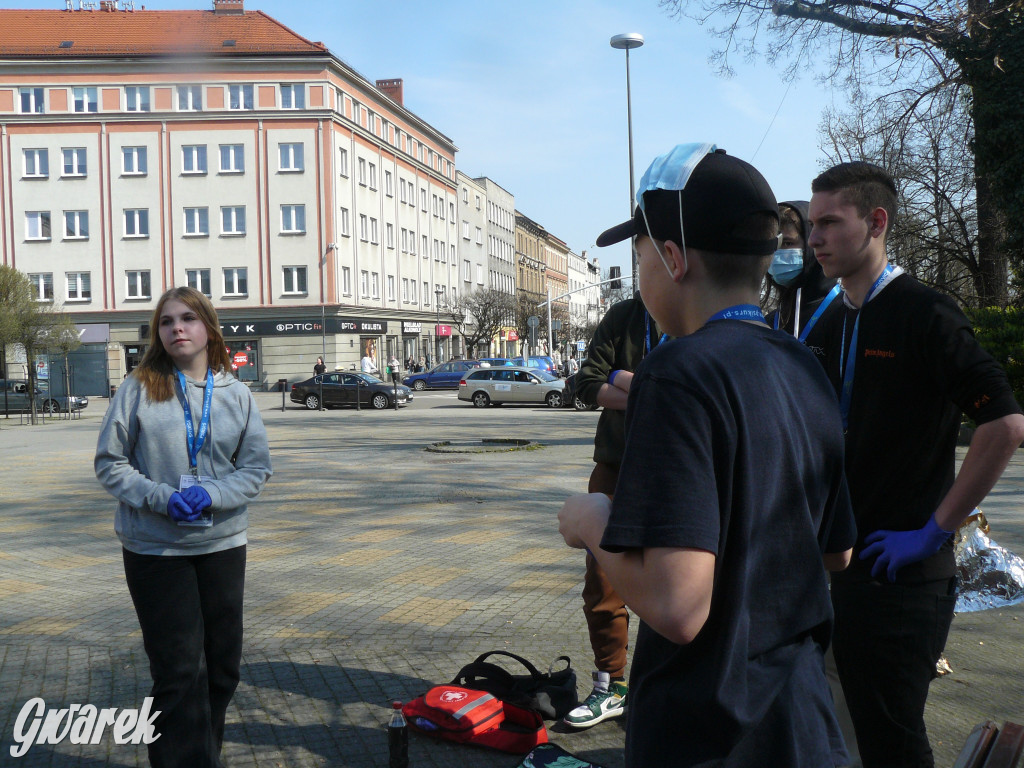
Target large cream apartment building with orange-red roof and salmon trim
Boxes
[0,0,464,394]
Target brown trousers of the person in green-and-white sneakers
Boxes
[583,463,630,678]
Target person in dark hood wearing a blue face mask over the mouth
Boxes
[764,200,840,342]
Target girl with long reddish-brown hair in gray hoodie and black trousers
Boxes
[95,288,270,768]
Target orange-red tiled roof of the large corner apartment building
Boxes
[0,6,328,58]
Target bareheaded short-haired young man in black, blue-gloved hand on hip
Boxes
[808,162,1024,768]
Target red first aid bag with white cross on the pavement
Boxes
[401,685,548,755]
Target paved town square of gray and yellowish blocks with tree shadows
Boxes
[0,393,1024,768]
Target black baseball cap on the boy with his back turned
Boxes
[597,150,778,256]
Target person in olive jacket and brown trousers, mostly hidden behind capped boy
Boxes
[564,294,662,728]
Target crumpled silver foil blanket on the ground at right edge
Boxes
[953,511,1024,613]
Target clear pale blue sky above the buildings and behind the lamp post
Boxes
[0,0,843,280]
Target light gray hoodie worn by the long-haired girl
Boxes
[95,372,270,555]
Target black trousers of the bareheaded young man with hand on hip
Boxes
[831,579,956,768]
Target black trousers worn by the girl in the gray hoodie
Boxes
[123,546,246,768]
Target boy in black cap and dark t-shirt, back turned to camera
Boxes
[559,145,855,768]
